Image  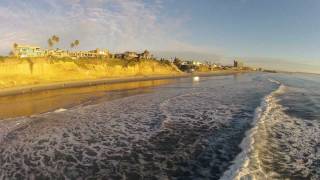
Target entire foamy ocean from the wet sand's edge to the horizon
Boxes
[0,73,320,179]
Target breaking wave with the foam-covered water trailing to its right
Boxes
[221,80,320,180]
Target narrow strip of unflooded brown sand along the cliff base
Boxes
[0,70,252,97]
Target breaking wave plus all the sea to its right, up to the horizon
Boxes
[222,74,320,180]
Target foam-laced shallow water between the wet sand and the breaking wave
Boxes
[0,75,280,179]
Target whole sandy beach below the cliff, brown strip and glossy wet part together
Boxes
[0,71,249,121]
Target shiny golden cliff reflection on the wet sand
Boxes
[0,79,174,119]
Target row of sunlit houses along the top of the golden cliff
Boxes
[12,44,153,60]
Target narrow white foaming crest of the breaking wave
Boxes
[221,79,286,180]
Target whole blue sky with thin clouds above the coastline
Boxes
[0,0,320,73]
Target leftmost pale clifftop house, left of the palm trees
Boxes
[12,44,45,58]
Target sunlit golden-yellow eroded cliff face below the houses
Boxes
[0,58,180,88]
